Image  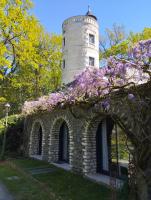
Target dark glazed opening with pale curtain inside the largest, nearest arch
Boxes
[96,118,129,178]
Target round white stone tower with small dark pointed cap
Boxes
[62,9,99,84]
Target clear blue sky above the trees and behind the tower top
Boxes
[32,0,151,34]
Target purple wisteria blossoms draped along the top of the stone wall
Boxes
[23,40,151,115]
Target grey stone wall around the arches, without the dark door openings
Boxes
[25,108,111,174]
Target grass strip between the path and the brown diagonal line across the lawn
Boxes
[0,163,57,200]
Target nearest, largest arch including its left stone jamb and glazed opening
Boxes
[83,116,128,179]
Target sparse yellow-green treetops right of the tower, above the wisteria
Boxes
[100,25,151,60]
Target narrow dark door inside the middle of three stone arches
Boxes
[59,122,69,163]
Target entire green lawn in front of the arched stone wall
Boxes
[0,159,127,200]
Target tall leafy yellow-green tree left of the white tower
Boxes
[0,0,62,113]
